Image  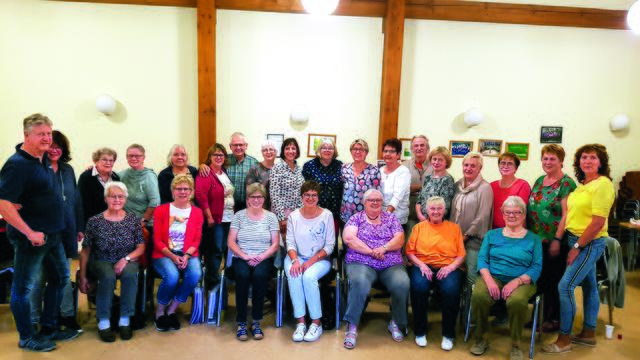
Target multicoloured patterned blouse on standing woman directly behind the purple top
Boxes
[340,163,380,223]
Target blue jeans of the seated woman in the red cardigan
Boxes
[153,257,202,305]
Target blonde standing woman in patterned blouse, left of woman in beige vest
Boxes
[415,146,456,221]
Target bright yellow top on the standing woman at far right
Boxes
[567,176,616,238]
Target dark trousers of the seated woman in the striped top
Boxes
[233,257,274,322]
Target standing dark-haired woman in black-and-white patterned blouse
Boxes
[269,138,304,236]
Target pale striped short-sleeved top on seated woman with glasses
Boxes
[231,209,280,256]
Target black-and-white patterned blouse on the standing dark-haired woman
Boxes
[269,161,304,221]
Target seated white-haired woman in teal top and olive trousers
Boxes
[471,196,542,360]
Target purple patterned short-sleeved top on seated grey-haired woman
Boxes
[344,211,403,270]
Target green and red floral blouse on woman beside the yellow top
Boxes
[527,174,576,242]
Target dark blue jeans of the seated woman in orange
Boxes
[409,266,465,339]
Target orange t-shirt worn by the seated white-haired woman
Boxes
[405,220,466,268]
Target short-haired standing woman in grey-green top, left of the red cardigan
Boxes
[120,144,160,225]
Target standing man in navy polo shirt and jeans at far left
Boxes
[0,114,79,352]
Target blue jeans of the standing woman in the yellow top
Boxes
[558,234,606,335]
